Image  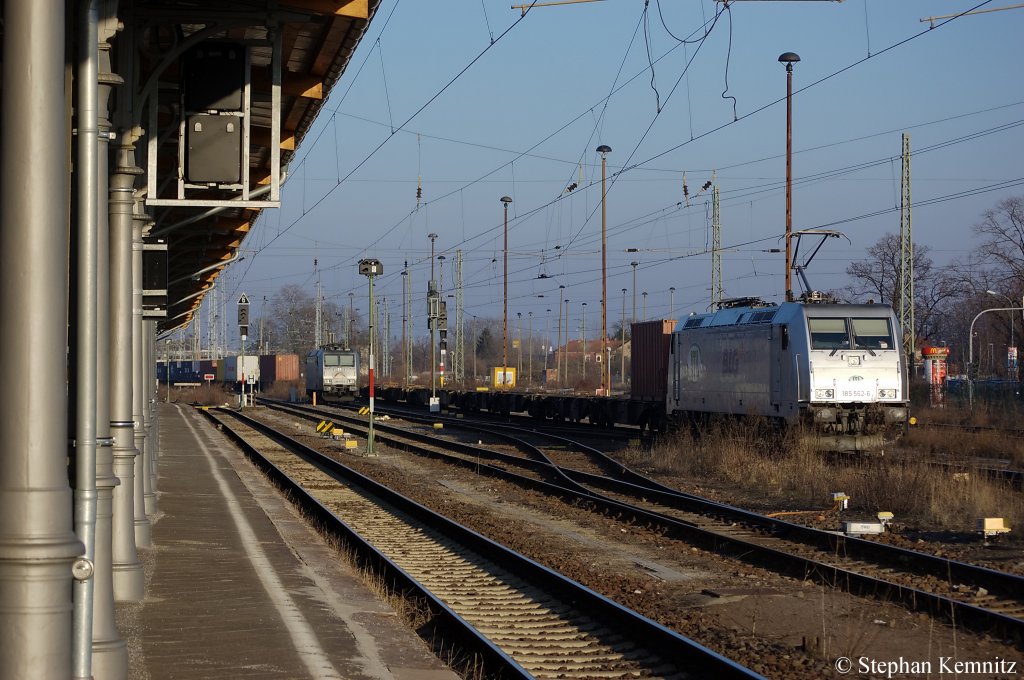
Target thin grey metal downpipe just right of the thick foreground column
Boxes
[72,0,99,678]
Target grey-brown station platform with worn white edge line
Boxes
[117,405,457,680]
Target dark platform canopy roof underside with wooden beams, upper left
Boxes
[119,0,380,331]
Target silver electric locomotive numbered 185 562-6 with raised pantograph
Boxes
[666,298,908,451]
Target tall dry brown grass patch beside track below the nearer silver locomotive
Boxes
[629,424,1024,532]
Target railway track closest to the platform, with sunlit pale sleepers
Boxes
[201,410,760,678]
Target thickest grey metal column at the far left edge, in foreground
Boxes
[0,0,84,678]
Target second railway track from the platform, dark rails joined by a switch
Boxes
[262,399,1024,644]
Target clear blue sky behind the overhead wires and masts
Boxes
[209,0,1024,337]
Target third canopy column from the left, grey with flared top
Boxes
[110,138,145,602]
